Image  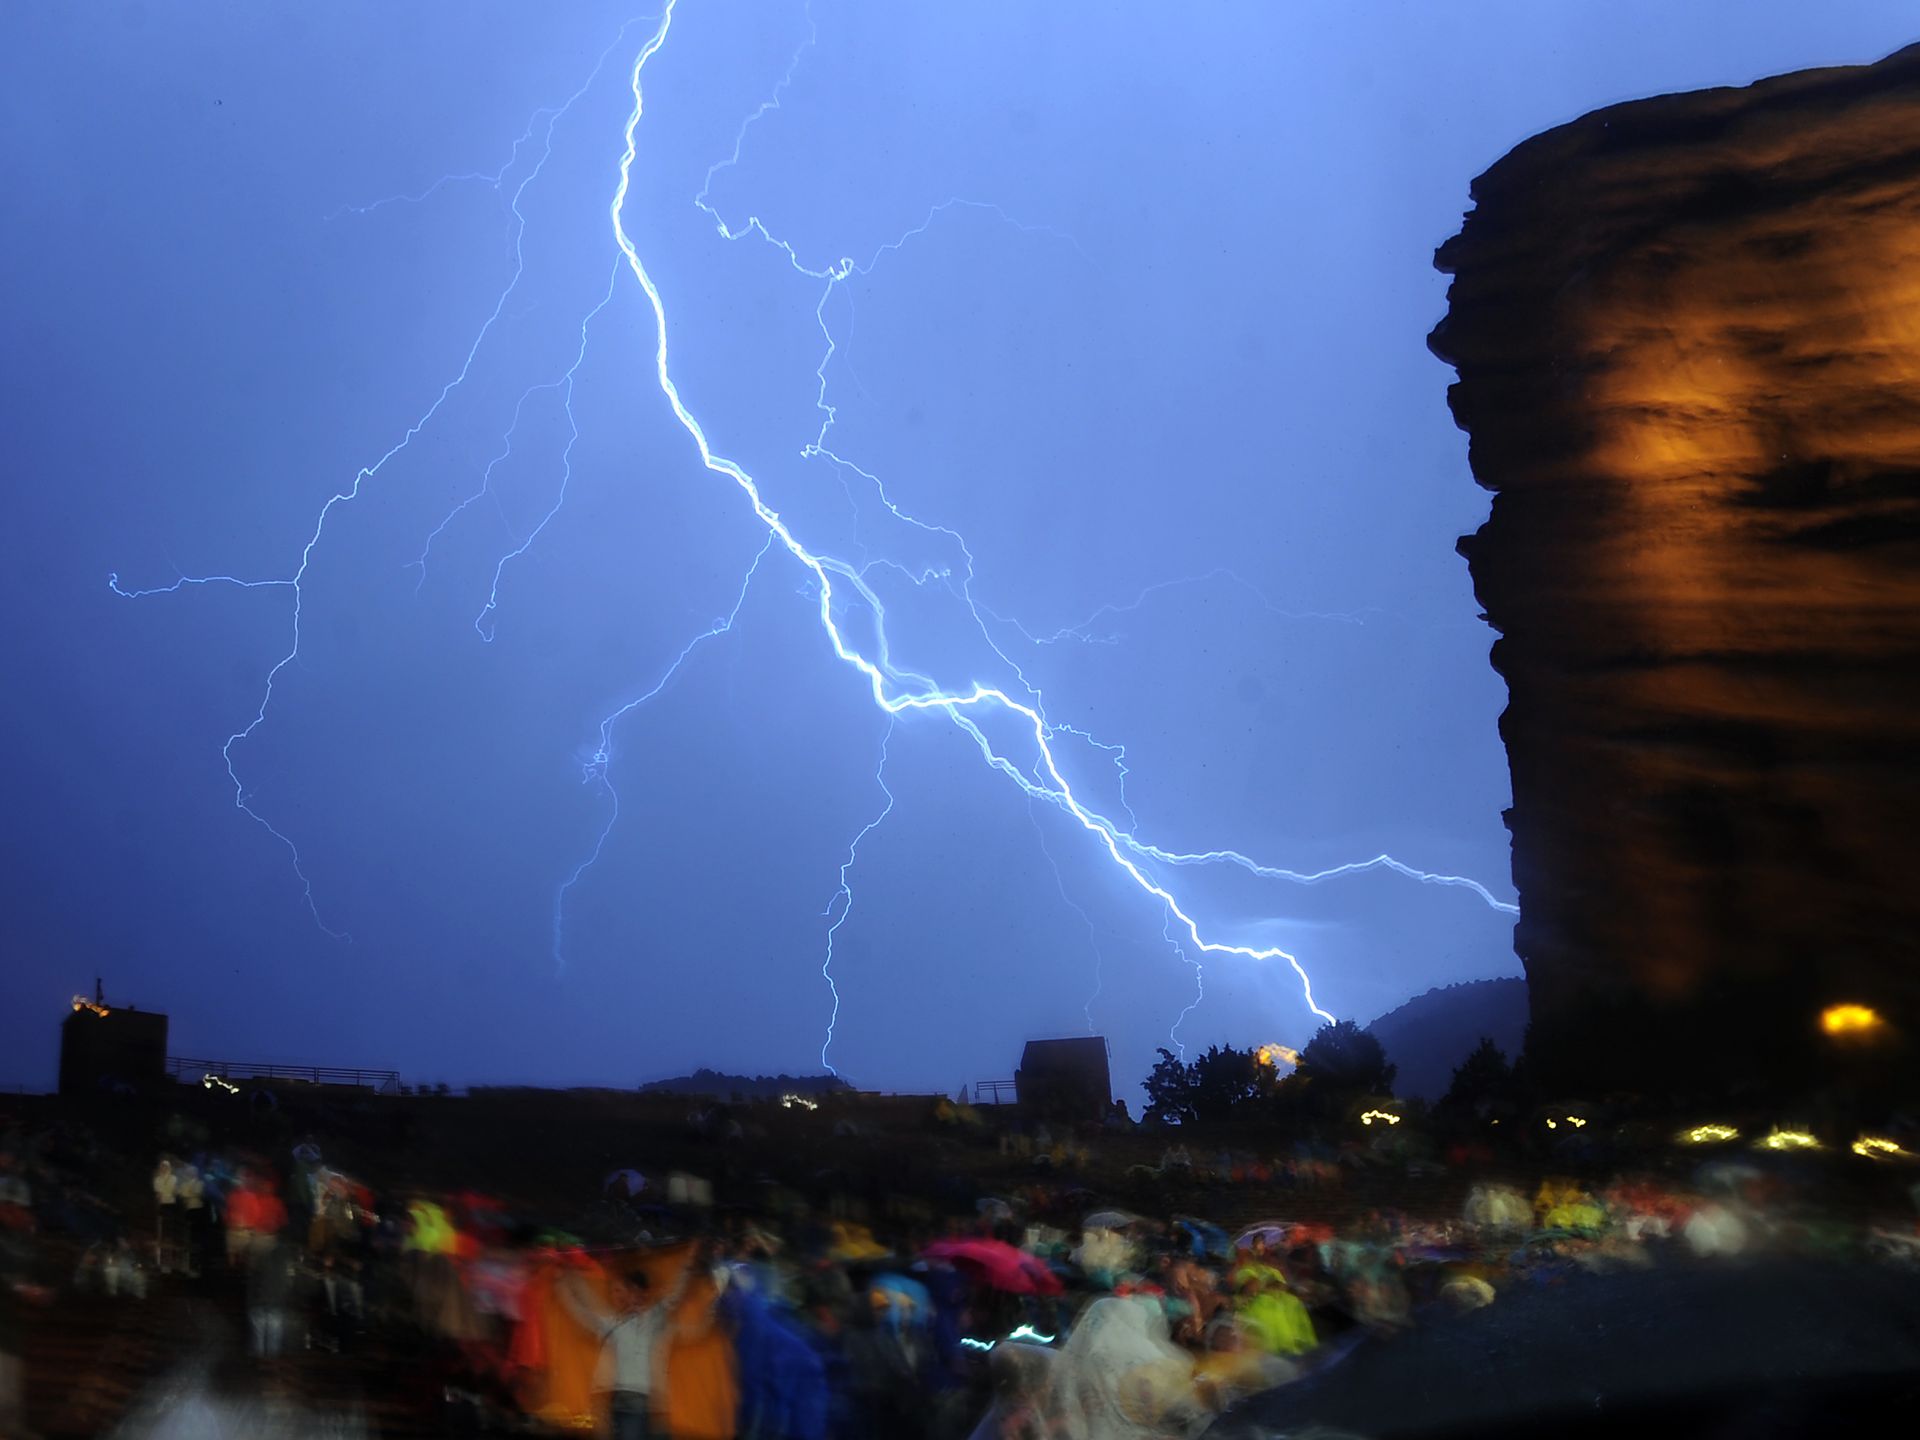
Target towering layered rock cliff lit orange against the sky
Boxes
[1428,46,1920,1091]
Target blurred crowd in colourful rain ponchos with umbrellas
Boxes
[0,1098,1920,1440]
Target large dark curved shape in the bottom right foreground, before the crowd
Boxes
[1208,1261,1920,1440]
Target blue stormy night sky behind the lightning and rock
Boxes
[0,0,1914,1096]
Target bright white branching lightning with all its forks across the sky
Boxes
[109,0,1517,1069]
